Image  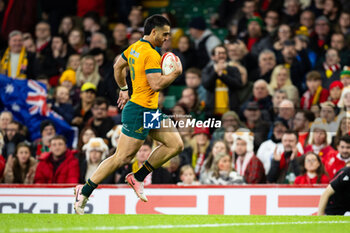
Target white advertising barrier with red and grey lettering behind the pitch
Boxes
[0,185,326,215]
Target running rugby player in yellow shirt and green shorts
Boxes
[74,15,183,214]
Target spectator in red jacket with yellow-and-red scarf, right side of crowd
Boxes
[300,71,329,110]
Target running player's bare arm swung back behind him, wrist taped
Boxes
[113,56,129,109]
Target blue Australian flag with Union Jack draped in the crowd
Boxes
[0,74,75,146]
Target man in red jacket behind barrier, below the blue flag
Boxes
[34,135,80,184]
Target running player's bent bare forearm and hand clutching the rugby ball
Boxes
[147,58,182,91]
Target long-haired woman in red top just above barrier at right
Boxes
[294,151,329,184]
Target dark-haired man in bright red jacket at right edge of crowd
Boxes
[322,135,350,179]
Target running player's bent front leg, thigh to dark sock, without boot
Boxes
[134,119,183,181]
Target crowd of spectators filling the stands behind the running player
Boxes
[0,0,350,185]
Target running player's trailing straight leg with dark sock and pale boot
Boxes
[74,133,144,214]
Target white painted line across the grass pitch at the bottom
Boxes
[10,221,350,232]
